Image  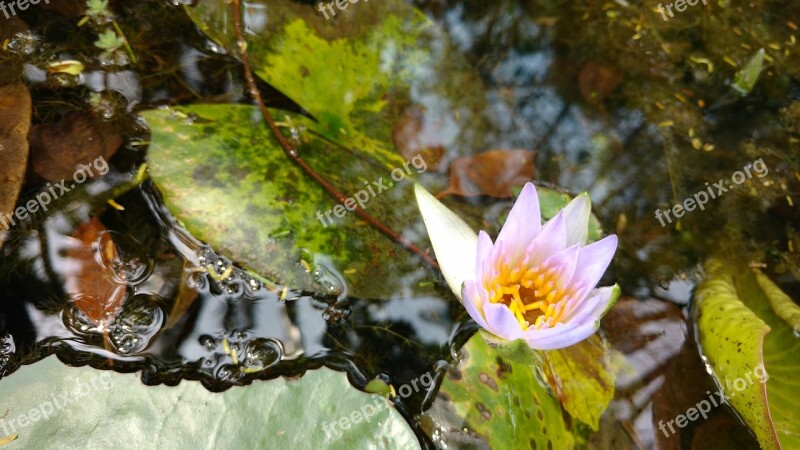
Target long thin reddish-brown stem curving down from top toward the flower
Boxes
[227,0,439,269]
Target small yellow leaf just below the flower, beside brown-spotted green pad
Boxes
[542,334,614,431]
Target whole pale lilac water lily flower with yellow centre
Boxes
[415,183,619,350]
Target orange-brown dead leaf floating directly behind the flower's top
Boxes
[436,150,535,198]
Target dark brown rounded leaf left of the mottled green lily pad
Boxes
[30,111,122,181]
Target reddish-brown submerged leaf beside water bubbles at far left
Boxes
[65,218,126,326]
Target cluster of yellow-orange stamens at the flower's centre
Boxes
[484,262,576,330]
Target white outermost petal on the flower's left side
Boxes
[414,183,478,300]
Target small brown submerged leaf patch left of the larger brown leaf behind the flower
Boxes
[392,107,444,172]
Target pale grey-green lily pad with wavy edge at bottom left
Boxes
[0,356,420,450]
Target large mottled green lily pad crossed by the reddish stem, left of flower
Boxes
[142,105,431,298]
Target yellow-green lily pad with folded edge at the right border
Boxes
[694,260,800,449]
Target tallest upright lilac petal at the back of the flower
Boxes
[497,183,542,259]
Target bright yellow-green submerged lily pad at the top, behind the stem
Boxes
[186,0,489,170]
